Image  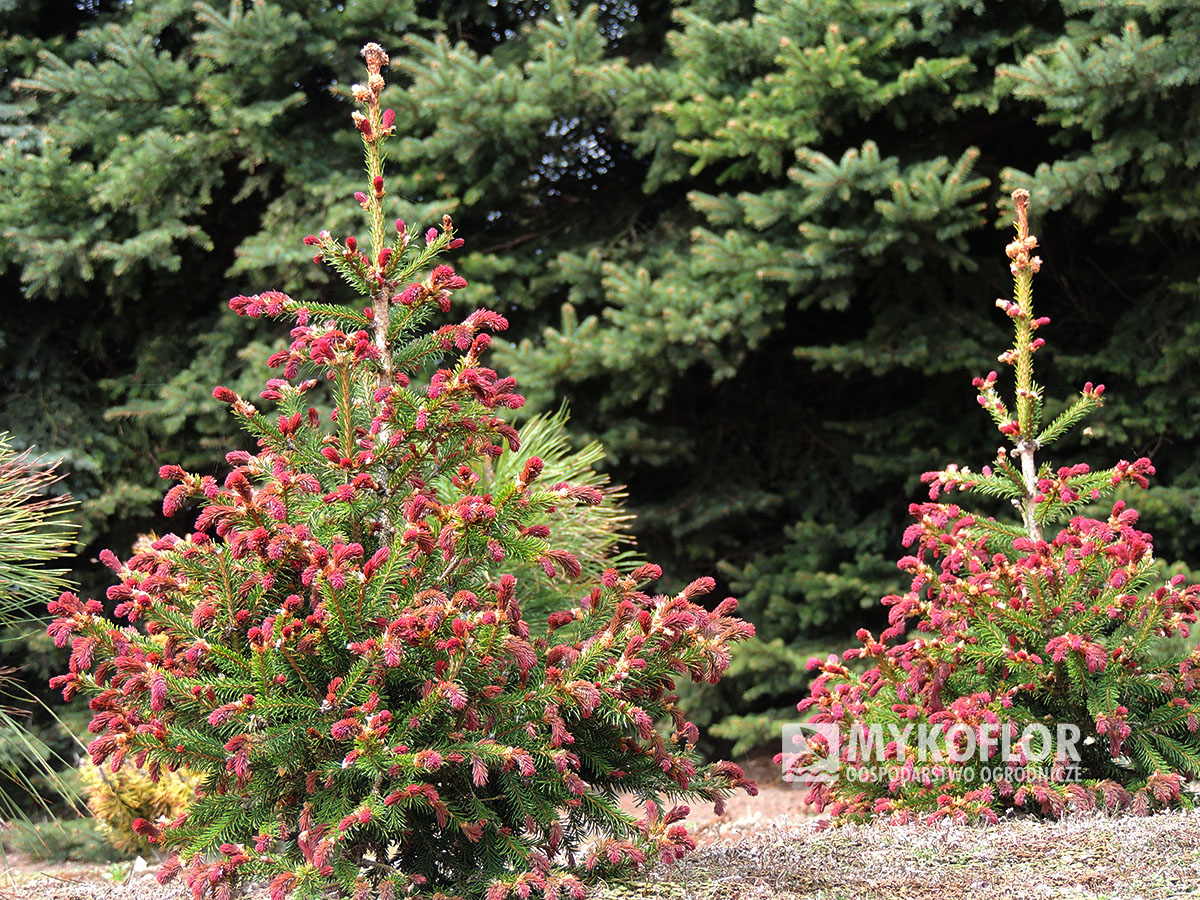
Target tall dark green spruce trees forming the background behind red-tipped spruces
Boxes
[0,0,1200,753]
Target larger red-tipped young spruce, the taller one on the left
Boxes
[49,44,755,900]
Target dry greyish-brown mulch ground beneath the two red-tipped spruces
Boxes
[7,762,1200,900]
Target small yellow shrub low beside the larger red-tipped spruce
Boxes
[79,762,197,854]
